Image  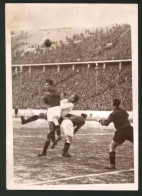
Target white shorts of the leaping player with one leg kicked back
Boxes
[47,106,61,122]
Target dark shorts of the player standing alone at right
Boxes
[113,126,133,144]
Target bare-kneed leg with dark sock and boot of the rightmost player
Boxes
[105,140,120,170]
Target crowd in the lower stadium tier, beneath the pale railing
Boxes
[12,63,132,111]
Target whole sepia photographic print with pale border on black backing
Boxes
[5,3,139,190]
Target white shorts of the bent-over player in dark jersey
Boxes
[60,119,74,137]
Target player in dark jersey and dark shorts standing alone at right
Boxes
[99,99,133,169]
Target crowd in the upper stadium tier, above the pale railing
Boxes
[12,24,131,64]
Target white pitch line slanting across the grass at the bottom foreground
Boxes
[23,169,134,186]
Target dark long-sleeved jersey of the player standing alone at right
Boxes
[101,107,130,130]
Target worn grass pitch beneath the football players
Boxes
[13,118,134,187]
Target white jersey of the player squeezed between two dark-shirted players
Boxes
[60,99,74,117]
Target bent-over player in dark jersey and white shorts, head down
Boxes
[61,113,87,157]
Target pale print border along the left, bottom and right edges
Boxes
[5,4,139,190]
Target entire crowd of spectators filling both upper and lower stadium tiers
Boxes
[11,24,132,111]
